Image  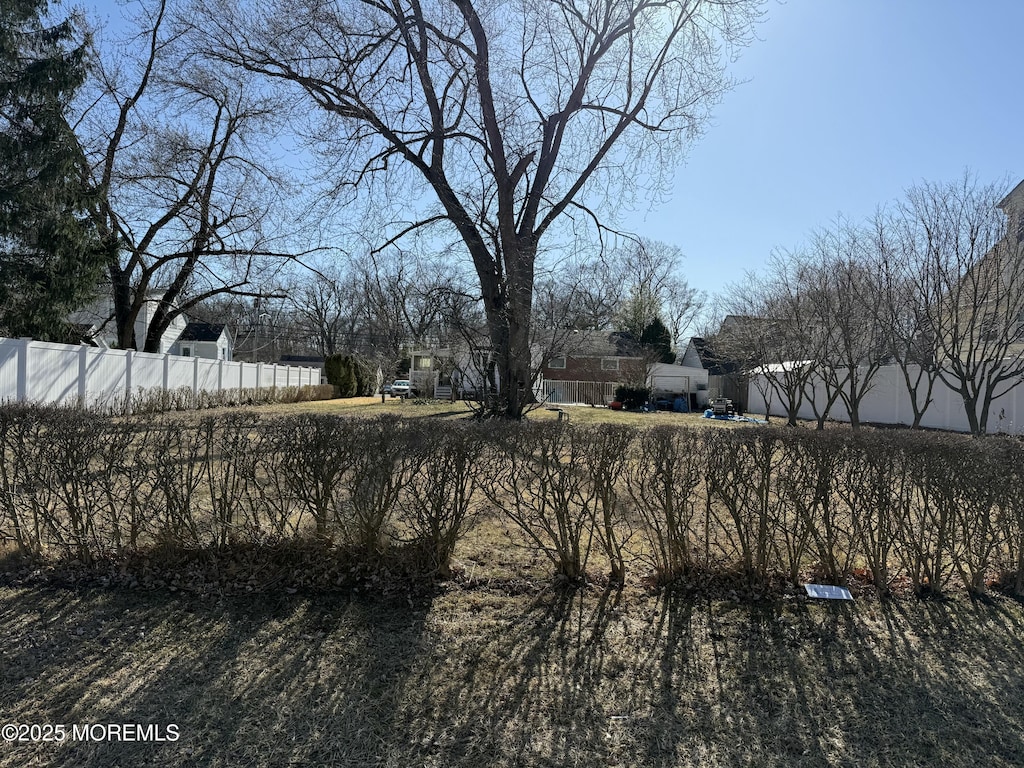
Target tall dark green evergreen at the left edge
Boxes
[0,0,102,339]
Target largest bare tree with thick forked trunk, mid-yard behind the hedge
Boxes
[197,0,760,418]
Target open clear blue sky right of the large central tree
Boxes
[625,0,1024,293]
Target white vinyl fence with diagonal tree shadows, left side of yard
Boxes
[0,337,321,410]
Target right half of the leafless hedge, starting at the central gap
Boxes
[486,425,1024,594]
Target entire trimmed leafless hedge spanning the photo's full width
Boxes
[0,406,1024,594]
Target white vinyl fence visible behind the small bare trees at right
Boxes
[746,366,1024,434]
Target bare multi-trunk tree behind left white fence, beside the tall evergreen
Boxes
[77,0,301,351]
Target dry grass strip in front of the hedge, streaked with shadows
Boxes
[0,583,1024,768]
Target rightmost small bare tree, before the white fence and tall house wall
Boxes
[899,173,1024,434]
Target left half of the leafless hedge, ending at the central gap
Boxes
[0,406,484,574]
